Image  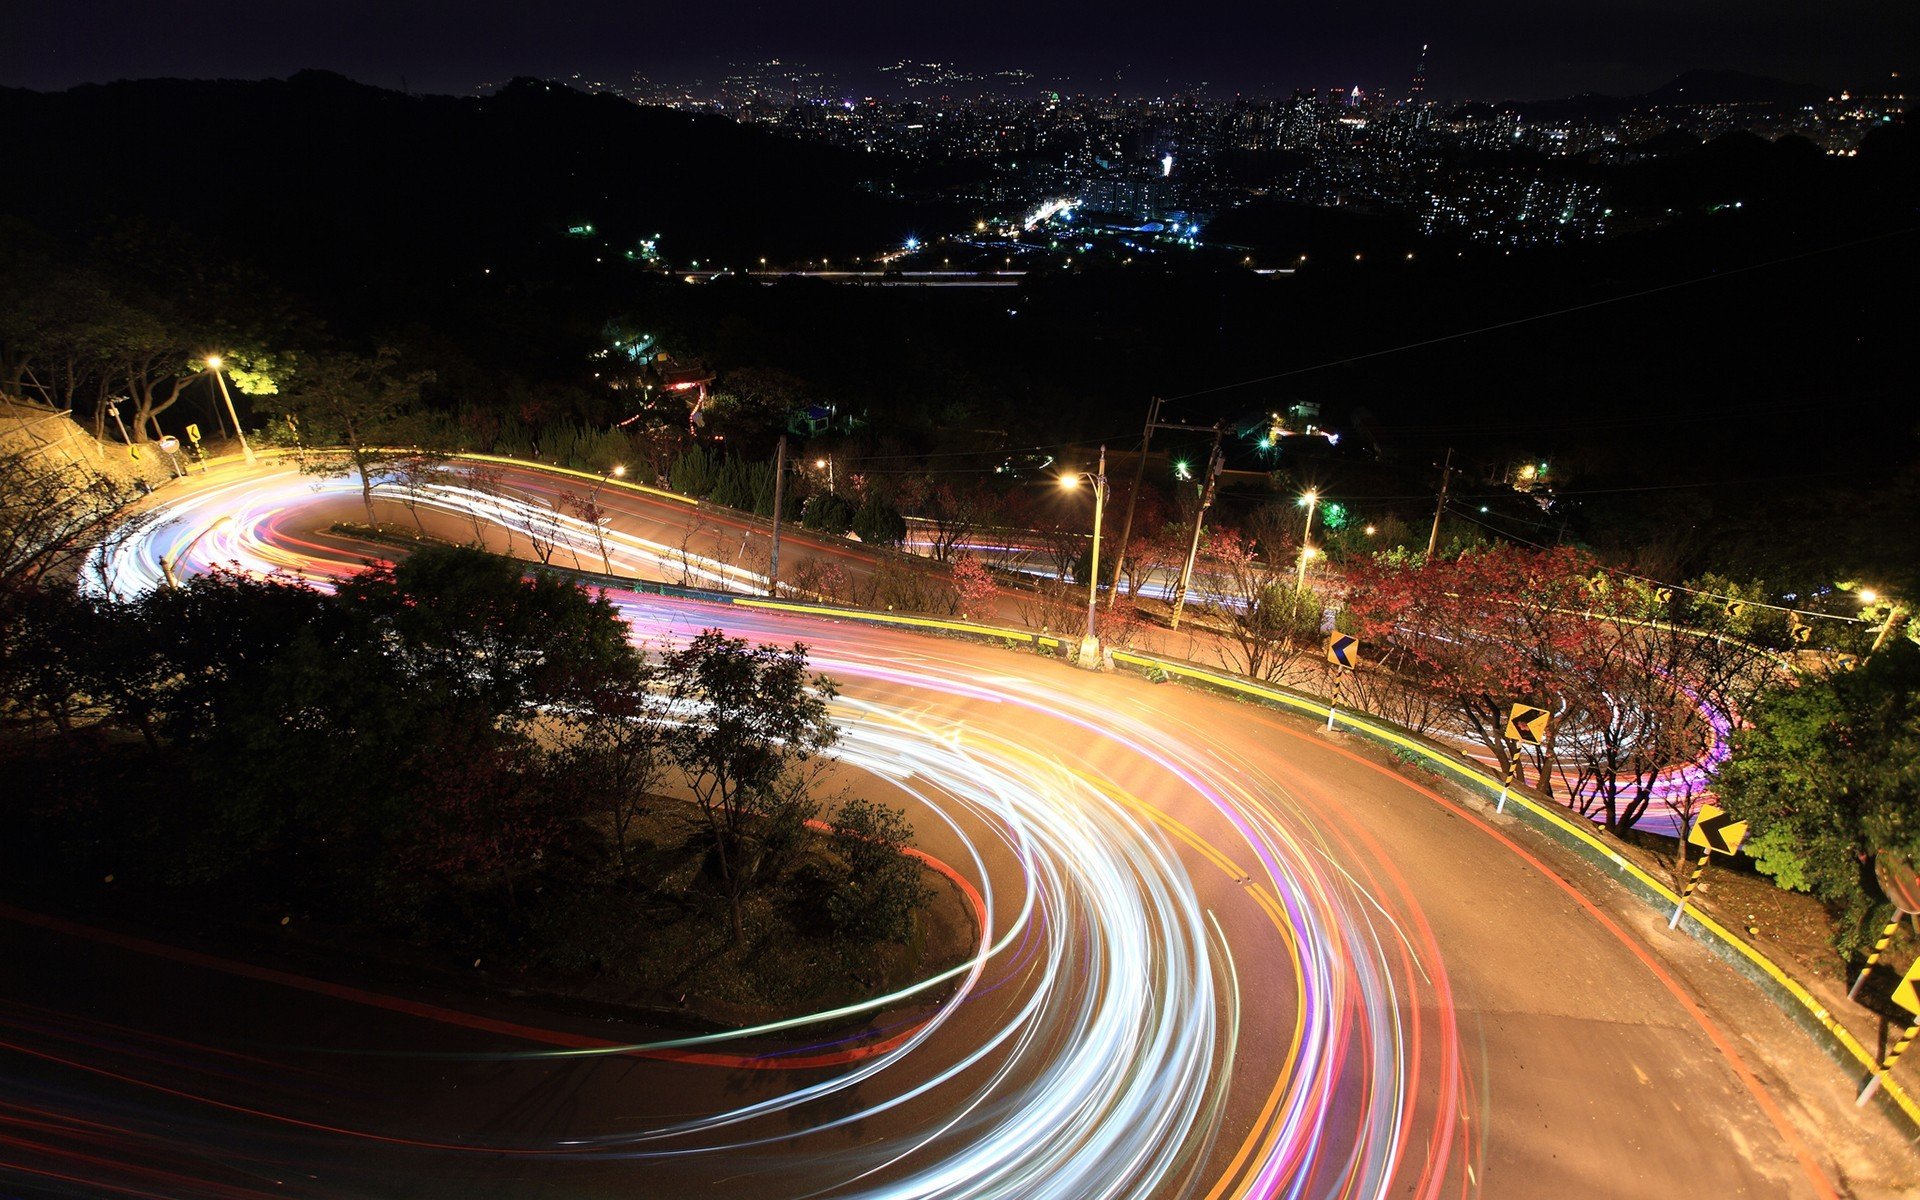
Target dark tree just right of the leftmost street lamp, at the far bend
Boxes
[278,348,434,528]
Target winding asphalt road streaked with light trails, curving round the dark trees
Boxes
[0,453,1881,1200]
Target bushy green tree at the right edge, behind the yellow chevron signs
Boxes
[1715,641,1920,950]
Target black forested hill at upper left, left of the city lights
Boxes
[0,71,929,311]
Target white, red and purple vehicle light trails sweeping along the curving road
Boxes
[41,462,1473,1200]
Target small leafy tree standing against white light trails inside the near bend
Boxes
[666,630,839,941]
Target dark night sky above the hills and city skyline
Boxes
[0,0,1920,98]
